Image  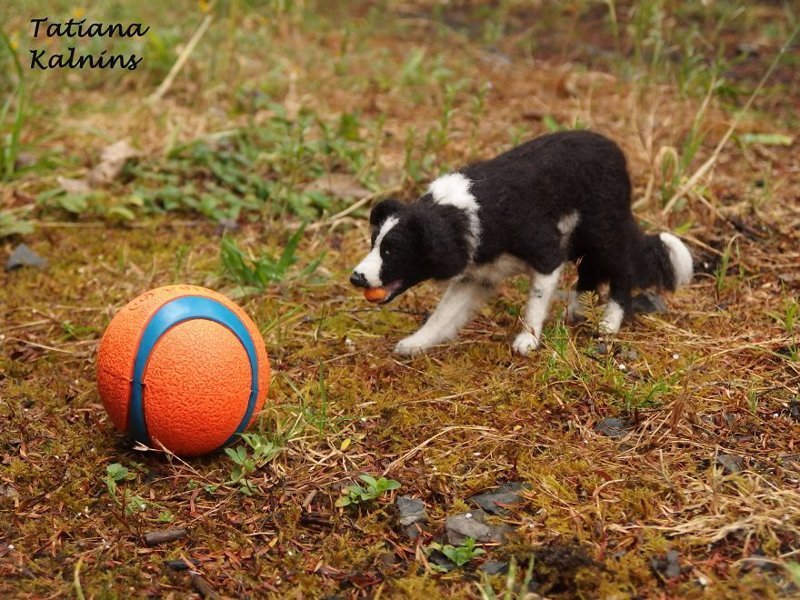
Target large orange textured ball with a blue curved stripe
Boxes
[97,285,270,456]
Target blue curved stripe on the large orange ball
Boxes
[128,296,258,446]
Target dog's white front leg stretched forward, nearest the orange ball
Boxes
[394,279,491,355]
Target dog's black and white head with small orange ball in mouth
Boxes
[350,200,468,304]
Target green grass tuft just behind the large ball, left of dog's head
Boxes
[220,223,325,294]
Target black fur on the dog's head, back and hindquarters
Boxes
[360,131,675,312]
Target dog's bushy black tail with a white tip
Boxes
[634,233,694,291]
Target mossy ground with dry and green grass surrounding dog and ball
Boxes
[0,0,800,598]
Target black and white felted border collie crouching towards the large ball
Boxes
[350,131,692,355]
